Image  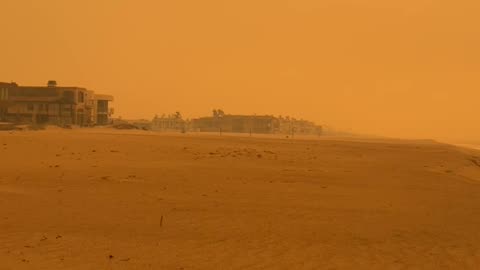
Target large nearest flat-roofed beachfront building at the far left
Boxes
[0,81,113,126]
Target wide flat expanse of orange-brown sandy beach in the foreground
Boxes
[0,129,480,270]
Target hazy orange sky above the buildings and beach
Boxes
[0,0,480,139]
